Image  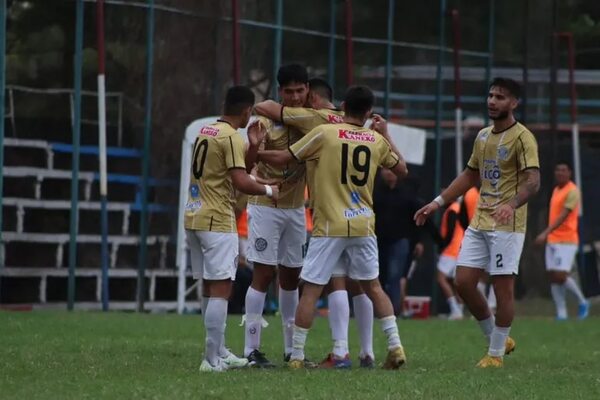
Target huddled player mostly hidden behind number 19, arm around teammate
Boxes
[254,78,375,368]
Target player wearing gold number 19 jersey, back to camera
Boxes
[260,86,407,369]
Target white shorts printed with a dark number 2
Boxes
[456,227,525,275]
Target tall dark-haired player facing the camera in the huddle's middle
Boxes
[243,64,308,368]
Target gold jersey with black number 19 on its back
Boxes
[290,123,398,237]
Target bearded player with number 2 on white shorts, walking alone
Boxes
[415,78,540,368]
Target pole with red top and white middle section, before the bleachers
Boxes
[96,0,109,311]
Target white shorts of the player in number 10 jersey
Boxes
[185,229,238,281]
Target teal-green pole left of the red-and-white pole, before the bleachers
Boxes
[67,0,83,311]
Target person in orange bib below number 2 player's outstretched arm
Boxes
[437,201,465,320]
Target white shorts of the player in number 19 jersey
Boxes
[300,236,379,285]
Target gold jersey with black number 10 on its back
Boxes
[185,120,246,232]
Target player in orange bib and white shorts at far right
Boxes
[535,161,590,320]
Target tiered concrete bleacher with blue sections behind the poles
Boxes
[0,138,185,309]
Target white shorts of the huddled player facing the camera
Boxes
[246,204,306,268]
